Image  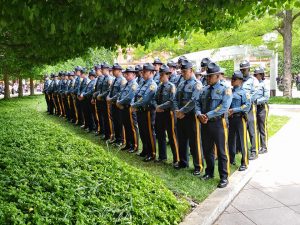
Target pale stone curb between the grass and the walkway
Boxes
[180,151,265,225]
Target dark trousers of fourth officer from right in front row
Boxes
[137,109,156,158]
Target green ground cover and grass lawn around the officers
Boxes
[0,96,288,224]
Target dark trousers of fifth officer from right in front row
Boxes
[121,105,139,151]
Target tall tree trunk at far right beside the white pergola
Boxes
[282,10,293,98]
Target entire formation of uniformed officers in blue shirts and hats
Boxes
[44,56,269,188]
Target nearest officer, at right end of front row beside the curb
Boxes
[196,63,232,188]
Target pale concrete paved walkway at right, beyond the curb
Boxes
[215,106,300,225]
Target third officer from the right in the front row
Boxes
[154,64,179,168]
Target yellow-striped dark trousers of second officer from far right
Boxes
[247,104,259,155]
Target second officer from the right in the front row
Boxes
[174,59,203,176]
